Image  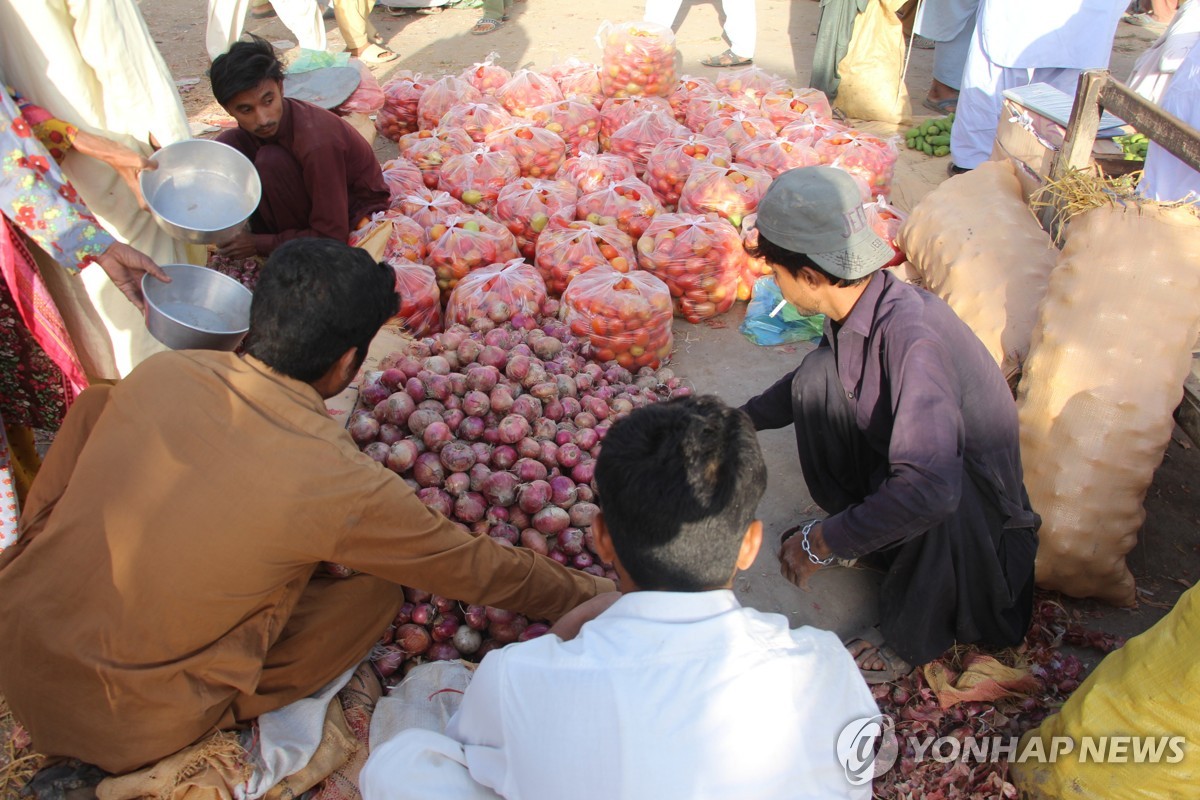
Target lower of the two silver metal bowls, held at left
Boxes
[142,264,253,350]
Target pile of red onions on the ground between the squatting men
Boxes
[348,309,690,680]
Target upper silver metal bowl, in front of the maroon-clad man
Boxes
[138,139,263,245]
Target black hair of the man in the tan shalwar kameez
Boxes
[246,239,400,383]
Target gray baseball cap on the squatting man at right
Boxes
[755,167,895,281]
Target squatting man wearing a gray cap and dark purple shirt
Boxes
[744,167,1040,682]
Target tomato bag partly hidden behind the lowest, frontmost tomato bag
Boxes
[534,217,637,297]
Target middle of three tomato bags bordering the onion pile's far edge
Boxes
[446,258,546,325]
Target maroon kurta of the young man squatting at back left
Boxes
[217,98,388,255]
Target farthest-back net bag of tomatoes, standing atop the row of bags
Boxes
[596,22,676,97]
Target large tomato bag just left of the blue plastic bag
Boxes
[637,213,746,323]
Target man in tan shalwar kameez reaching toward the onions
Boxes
[0,239,612,772]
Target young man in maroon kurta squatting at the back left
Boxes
[209,37,388,258]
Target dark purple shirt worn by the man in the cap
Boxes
[744,271,1037,558]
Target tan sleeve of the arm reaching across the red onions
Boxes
[332,457,614,620]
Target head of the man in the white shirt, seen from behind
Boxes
[595,395,767,591]
